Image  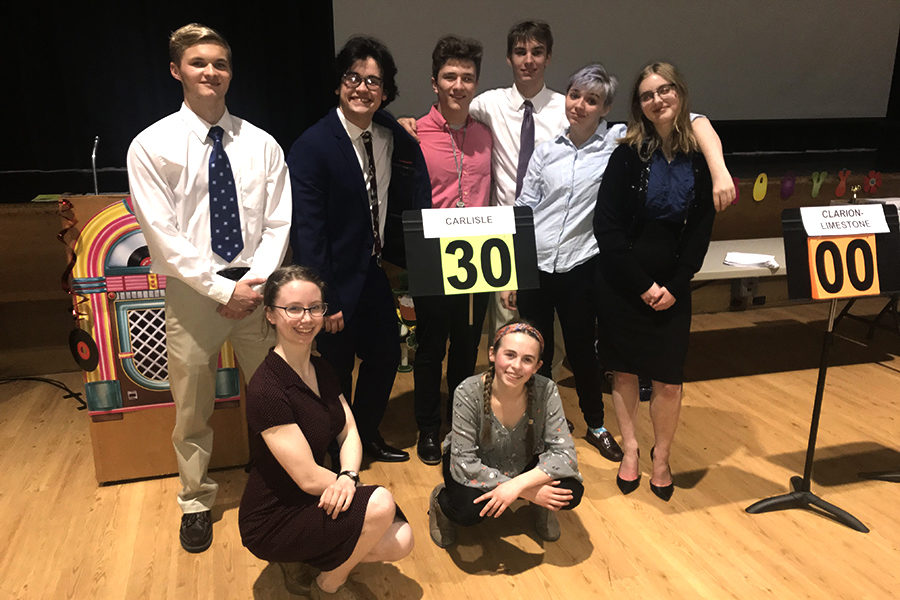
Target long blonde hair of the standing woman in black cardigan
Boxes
[619,62,700,160]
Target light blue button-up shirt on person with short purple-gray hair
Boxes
[516,120,626,273]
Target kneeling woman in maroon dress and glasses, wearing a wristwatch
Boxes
[239,266,413,598]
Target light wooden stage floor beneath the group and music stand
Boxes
[0,300,900,600]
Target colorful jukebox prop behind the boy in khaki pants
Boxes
[69,198,248,483]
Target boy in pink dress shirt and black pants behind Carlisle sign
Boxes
[414,36,492,464]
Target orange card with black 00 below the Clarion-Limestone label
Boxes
[807,234,881,300]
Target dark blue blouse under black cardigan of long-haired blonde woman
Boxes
[643,150,694,223]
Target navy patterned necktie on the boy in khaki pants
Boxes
[208,125,244,262]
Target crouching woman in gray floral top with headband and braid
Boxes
[429,320,584,548]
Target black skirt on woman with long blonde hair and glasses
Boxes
[597,220,691,384]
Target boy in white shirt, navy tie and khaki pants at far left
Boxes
[128,23,291,552]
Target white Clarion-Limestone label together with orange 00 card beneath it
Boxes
[800,205,890,300]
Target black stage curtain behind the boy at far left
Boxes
[0,0,335,202]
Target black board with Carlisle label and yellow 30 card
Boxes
[403,206,539,296]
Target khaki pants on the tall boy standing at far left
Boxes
[166,277,275,513]
